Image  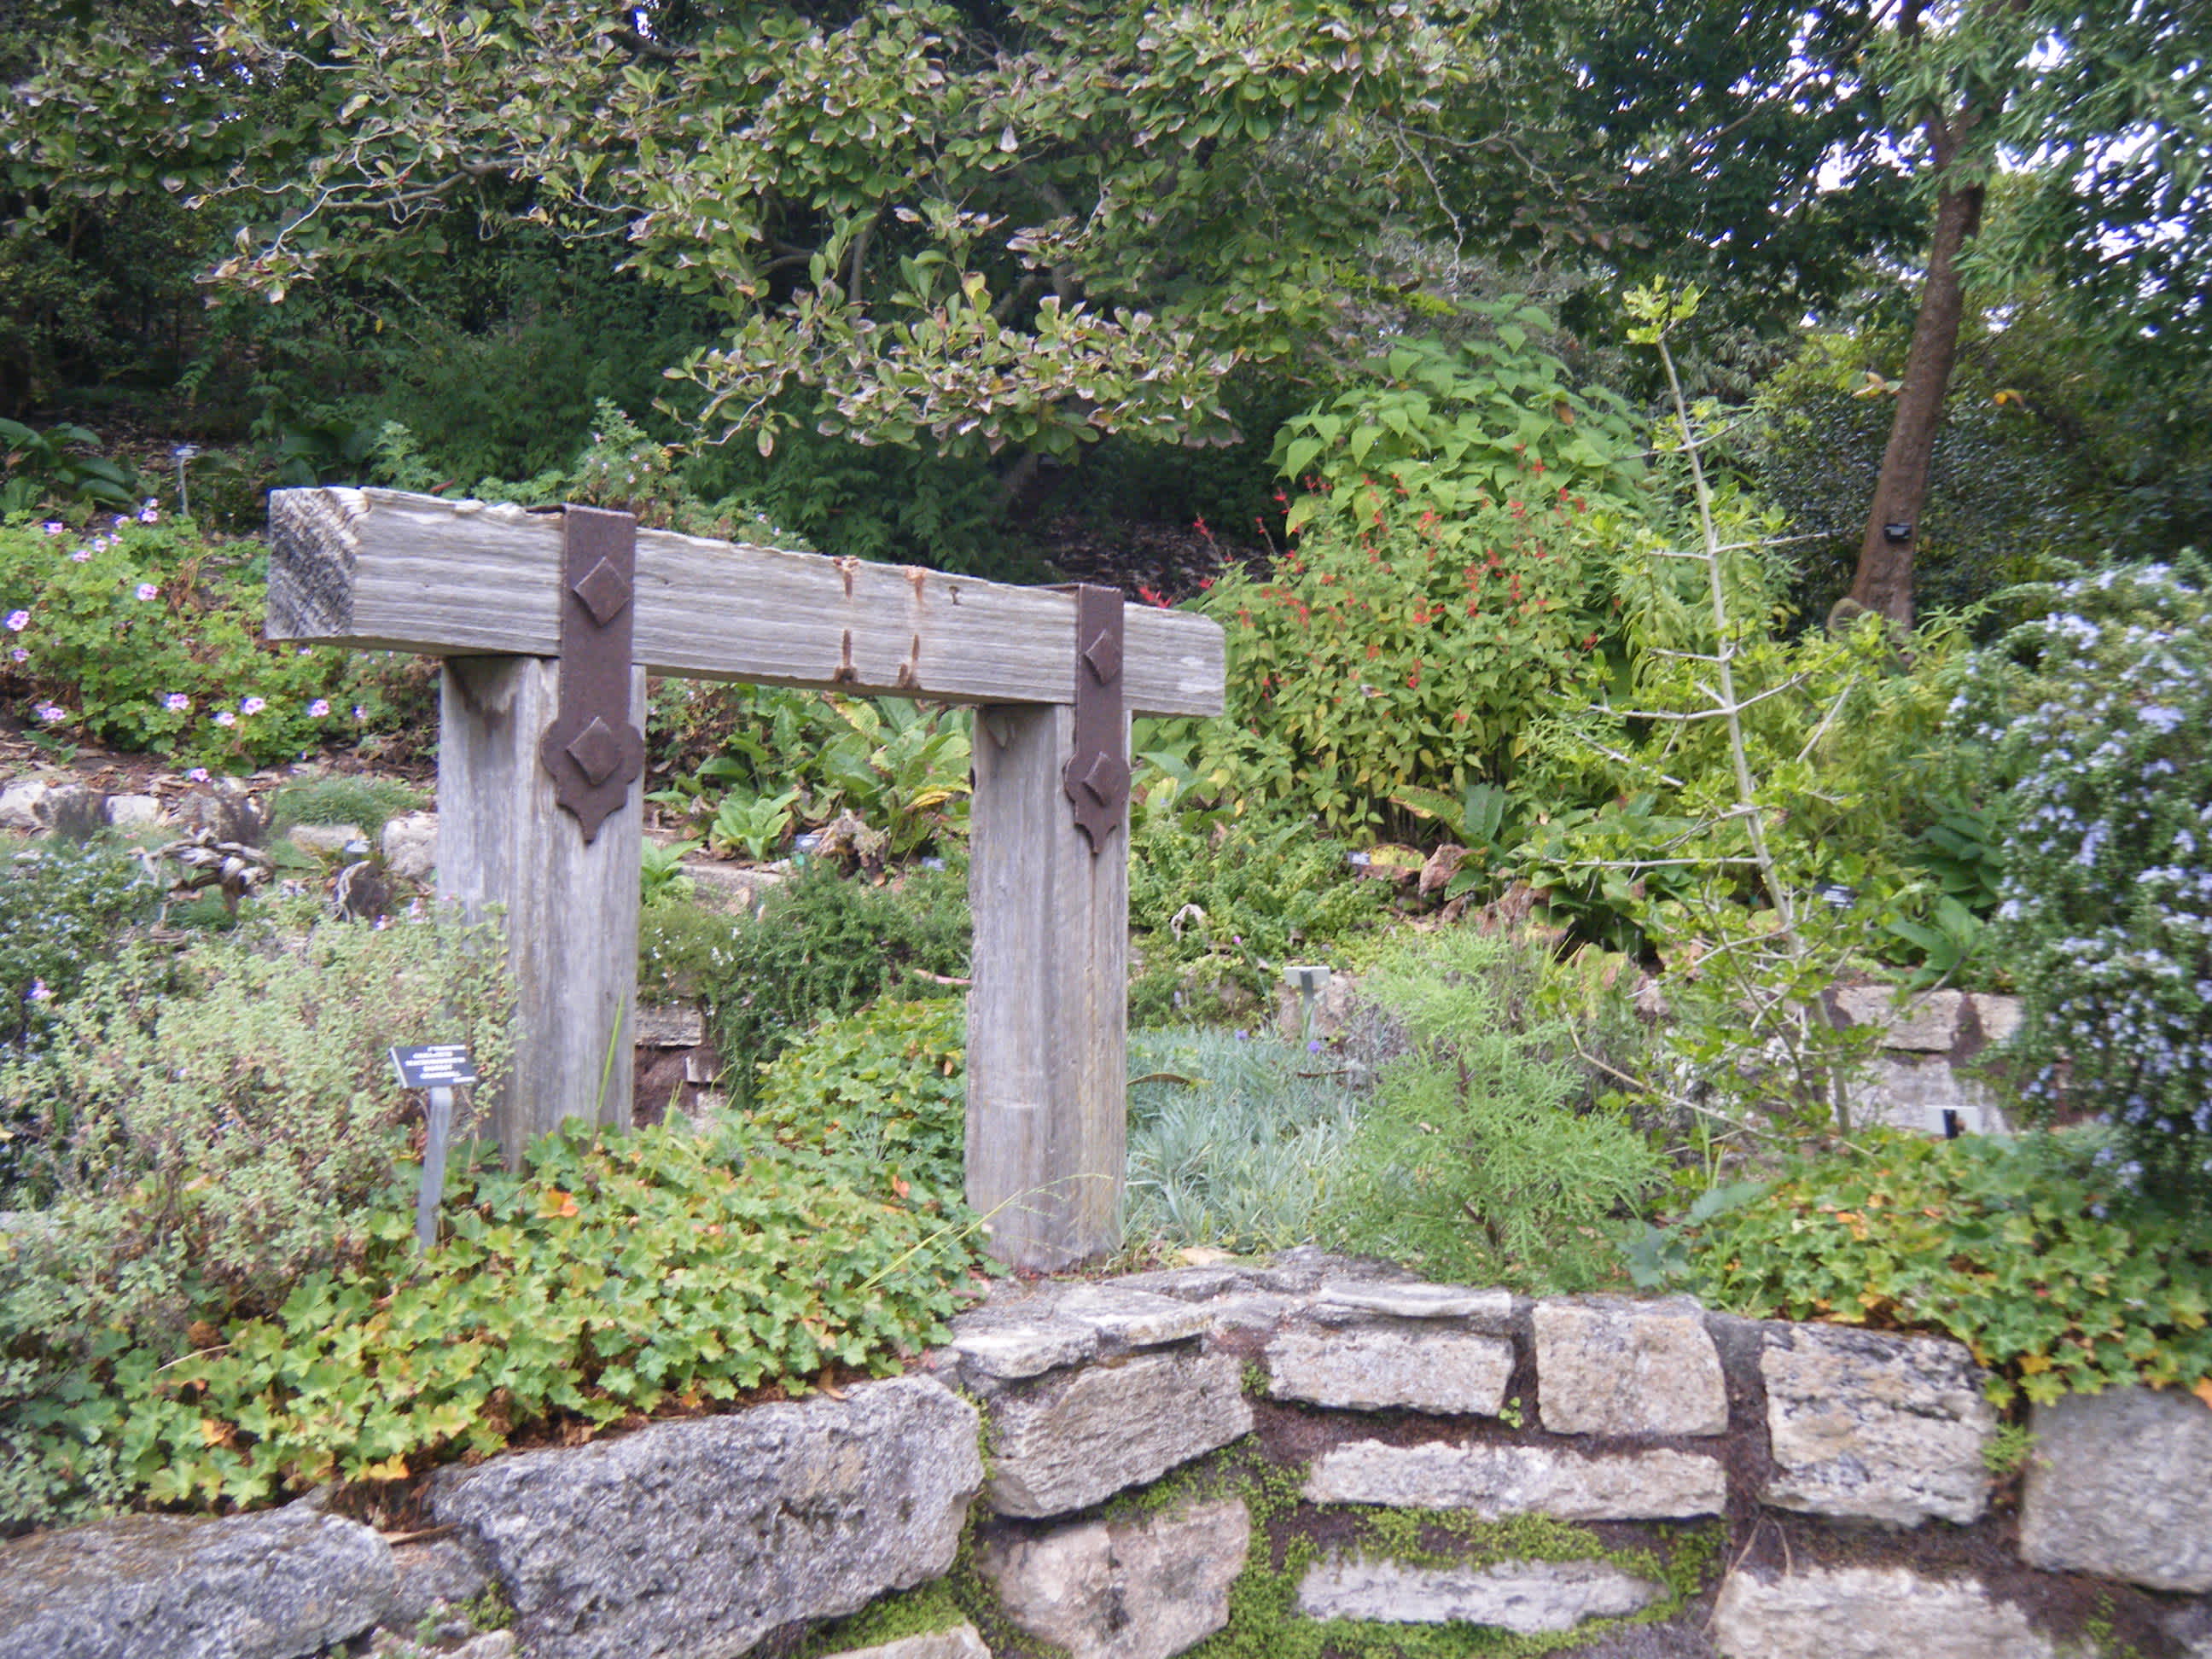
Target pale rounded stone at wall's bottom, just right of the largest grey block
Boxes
[978,1498,1252,1659]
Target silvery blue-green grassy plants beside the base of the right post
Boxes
[1124,1028,1358,1252]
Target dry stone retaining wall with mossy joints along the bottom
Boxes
[0,1252,2212,1659]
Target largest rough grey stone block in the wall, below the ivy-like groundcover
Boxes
[429,1376,982,1659]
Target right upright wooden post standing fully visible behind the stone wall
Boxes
[967,706,1128,1270]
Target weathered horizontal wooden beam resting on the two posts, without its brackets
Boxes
[268,489,1223,714]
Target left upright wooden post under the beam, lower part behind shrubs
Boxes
[438,657,646,1163]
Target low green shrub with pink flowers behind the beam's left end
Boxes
[0,504,378,770]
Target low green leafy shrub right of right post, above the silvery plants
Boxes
[1128,799,1391,1027]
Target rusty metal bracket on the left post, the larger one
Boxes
[538,507,646,841]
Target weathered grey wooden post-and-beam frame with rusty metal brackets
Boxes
[268,489,1223,1267]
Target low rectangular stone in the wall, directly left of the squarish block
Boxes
[1267,1320,1513,1417]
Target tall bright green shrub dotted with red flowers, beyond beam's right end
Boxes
[1199,306,1648,830]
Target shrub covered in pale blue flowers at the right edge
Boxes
[1976,560,2212,1203]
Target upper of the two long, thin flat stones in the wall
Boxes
[1305,1440,1727,1520]
